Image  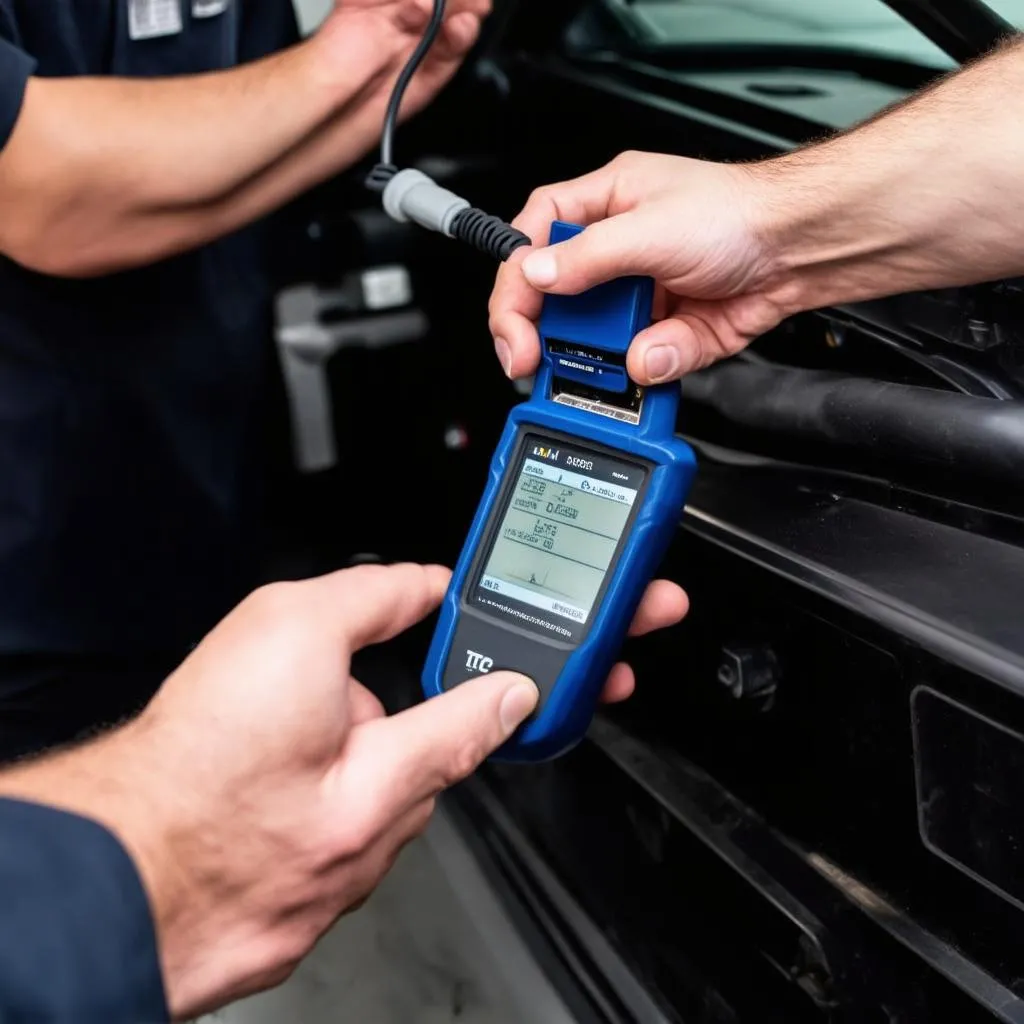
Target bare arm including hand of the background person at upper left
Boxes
[0,0,489,276]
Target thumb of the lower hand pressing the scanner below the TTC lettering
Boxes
[344,672,540,816]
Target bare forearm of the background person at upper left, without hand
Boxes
[0,16,391,274]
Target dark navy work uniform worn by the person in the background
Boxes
[0,0,297,760]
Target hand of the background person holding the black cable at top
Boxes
[321,0,492,118]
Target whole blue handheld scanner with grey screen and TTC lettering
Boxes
[423,222,696,762]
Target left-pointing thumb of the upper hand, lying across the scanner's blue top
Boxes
[522,212,647,295]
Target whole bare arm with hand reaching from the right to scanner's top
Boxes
[490,42,1024,383]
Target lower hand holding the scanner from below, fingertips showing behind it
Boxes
[0,565,686,1017]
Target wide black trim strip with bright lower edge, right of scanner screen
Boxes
[682,464,1024,696]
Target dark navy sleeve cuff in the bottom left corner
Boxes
[0,800,168,1024]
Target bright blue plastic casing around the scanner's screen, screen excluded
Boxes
[423,221,696,761]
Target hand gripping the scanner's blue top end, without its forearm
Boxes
[490,153,788,384]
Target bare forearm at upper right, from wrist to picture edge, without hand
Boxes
[751,35,1024,309]
